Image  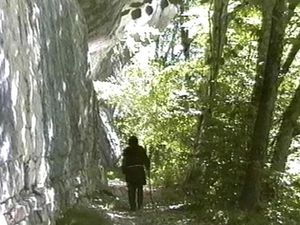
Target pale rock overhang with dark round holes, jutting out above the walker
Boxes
[78,0,180,80]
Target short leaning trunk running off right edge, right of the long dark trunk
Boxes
[272,85,300,172]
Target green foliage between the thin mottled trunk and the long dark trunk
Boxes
[180,5,259,207]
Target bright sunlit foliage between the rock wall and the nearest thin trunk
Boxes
[112,62,204,184]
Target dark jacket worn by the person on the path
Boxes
[122,145,150,185]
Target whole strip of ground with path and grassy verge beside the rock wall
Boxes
[57,180,207,225]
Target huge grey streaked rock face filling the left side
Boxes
[0,0,177,225]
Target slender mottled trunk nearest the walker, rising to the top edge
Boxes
[190,0,229,191]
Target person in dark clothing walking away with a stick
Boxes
[122,136,150,211]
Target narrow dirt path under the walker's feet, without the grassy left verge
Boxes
[93,181,201,225]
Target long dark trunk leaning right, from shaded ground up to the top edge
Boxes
[240,0,286,211]
